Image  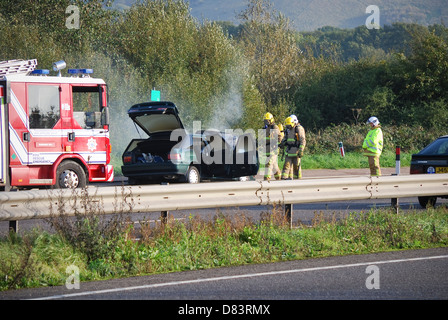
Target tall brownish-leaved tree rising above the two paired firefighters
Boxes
[239,0,301,107]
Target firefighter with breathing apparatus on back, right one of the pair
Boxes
[280,117,306,180]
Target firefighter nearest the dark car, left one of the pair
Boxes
[264,112,281,180]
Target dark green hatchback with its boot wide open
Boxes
[121,101,259,184]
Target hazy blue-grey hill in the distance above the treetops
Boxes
[114,0,448,31]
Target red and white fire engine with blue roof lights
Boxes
[0,59,113,190]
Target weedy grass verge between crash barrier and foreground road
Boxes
[0,206,448,290]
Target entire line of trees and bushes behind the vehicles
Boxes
[0,0,448,155]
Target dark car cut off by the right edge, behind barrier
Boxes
[410,135,448,208]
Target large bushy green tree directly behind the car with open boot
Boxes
[116,0,250,125]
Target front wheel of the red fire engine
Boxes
[55,161,86,189]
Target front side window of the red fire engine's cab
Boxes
[72,86,105,129]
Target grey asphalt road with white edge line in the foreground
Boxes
[0,248,448,302]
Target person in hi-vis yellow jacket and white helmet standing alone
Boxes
[362,117,383,176]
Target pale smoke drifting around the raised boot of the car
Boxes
[105,56,248,171]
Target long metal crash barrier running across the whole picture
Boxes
[0,174,448,231]
